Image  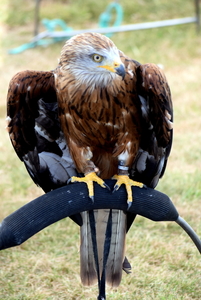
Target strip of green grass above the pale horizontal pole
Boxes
[0,0,195,27]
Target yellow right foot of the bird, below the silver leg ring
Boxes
[112,175,144,209]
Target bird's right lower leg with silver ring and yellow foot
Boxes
[112,160,144,208]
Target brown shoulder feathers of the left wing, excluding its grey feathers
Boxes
[7,70,57,159]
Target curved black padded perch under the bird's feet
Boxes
[0,180,201,299]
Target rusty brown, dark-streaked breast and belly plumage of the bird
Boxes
[56,45,141,173]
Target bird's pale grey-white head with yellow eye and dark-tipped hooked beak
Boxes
[60,33,125,87]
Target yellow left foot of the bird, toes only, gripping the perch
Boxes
[70,172,110,202]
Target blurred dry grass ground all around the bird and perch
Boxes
[0,0,201,300]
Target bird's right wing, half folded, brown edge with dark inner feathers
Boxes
[131,64,173,188]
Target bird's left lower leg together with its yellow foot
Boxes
[69,160,110,201]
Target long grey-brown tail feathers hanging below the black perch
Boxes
[80,209,127,287]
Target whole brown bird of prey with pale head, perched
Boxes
[7,33,173,287]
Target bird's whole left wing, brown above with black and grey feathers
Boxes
[7,71,76,192]
